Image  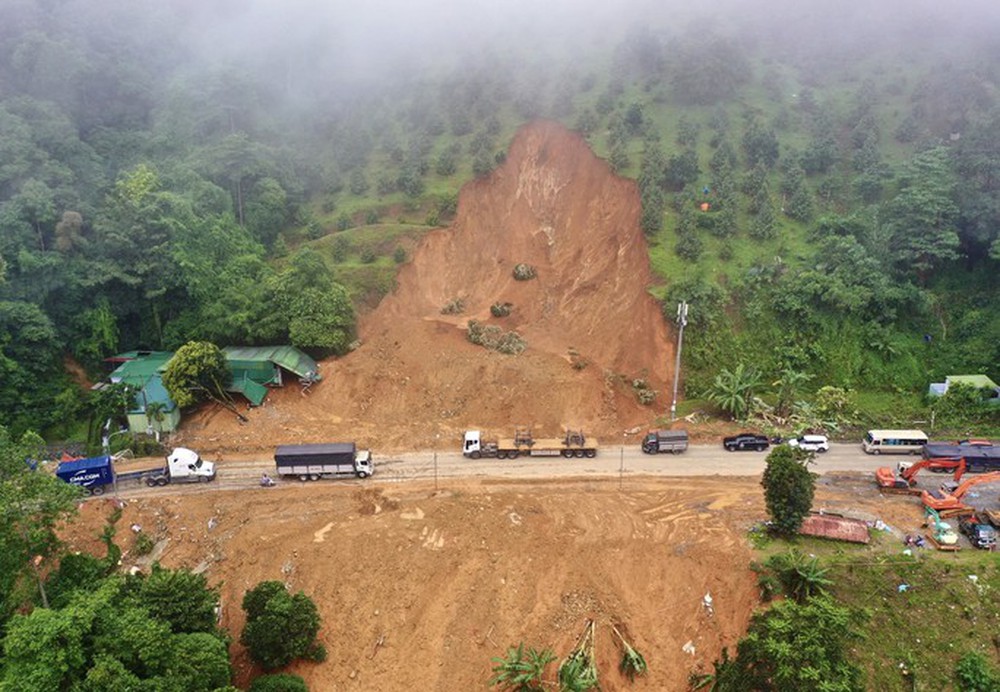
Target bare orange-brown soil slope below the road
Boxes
[58,477,917,692]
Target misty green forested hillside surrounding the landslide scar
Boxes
[0,0,1000,436]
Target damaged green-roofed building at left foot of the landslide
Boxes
[108,346,321,433]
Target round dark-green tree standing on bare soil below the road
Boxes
[240,581,326,670]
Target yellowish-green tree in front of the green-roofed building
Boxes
[163,341,246,420]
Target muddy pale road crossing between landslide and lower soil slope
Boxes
[109,444,914,496]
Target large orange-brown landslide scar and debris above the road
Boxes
[178,122,673,451]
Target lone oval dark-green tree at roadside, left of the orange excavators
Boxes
[760,445,816,535]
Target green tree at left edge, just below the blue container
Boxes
[0,426,80,624]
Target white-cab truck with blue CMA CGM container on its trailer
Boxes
[56,447,215,495]
